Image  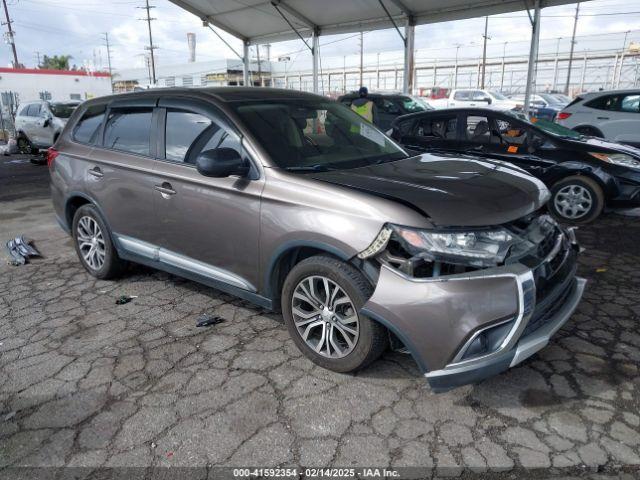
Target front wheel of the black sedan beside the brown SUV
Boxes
[549,175,605,224]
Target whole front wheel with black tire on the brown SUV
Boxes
[281,255,389,373]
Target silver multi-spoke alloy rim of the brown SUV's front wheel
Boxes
[291,275,360,358]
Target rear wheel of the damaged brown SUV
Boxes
[71,204,126,280]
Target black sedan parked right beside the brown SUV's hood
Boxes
[391,108,640,223]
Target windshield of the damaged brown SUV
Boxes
[231,99,408,170]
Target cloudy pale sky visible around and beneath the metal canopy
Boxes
[0,0,640,72]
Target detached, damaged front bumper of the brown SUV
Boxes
[362,231,586,391]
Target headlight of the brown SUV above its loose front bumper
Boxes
[391,225,516,267]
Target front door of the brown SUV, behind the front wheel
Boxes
[154,97,264,291]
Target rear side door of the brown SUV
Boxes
[85,97,158,248]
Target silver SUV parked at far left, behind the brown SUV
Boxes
[16,100,80,153]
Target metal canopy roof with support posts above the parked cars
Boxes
[171,0,575,111]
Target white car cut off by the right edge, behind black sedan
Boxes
[556,90,640,146]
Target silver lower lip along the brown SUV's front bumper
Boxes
[425,277,587,391]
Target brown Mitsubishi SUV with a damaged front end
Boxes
[48,88,585,389]
